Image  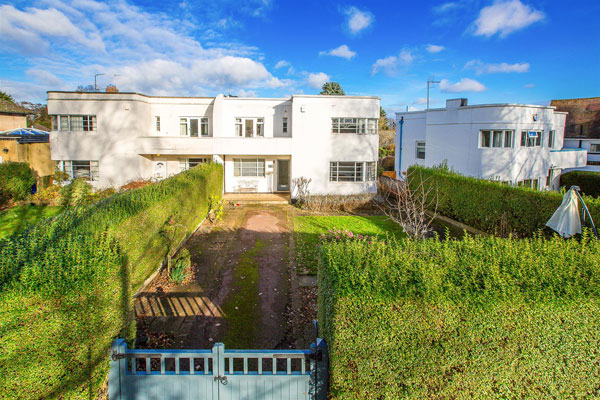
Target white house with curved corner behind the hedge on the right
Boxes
[395,99,587,190]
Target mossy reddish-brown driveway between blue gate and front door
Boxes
[134,205,314,349]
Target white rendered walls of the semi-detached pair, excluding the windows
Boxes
[48,92,379,194]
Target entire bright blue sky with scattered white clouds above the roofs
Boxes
[0,0,600,112]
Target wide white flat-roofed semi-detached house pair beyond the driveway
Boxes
[48,91,379,196]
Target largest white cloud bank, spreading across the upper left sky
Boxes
[0,0,293,99]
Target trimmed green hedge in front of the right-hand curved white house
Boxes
[408,166,600,236]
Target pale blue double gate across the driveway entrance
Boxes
[108,339,328,400]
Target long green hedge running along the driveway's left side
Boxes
[0,164,223,399]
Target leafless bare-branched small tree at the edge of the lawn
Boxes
[376,172,438,239]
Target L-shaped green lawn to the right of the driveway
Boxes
[294,215,406,275]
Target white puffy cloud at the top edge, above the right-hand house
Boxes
[474,0,545,38]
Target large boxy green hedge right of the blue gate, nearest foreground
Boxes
[319,236,600,399]
